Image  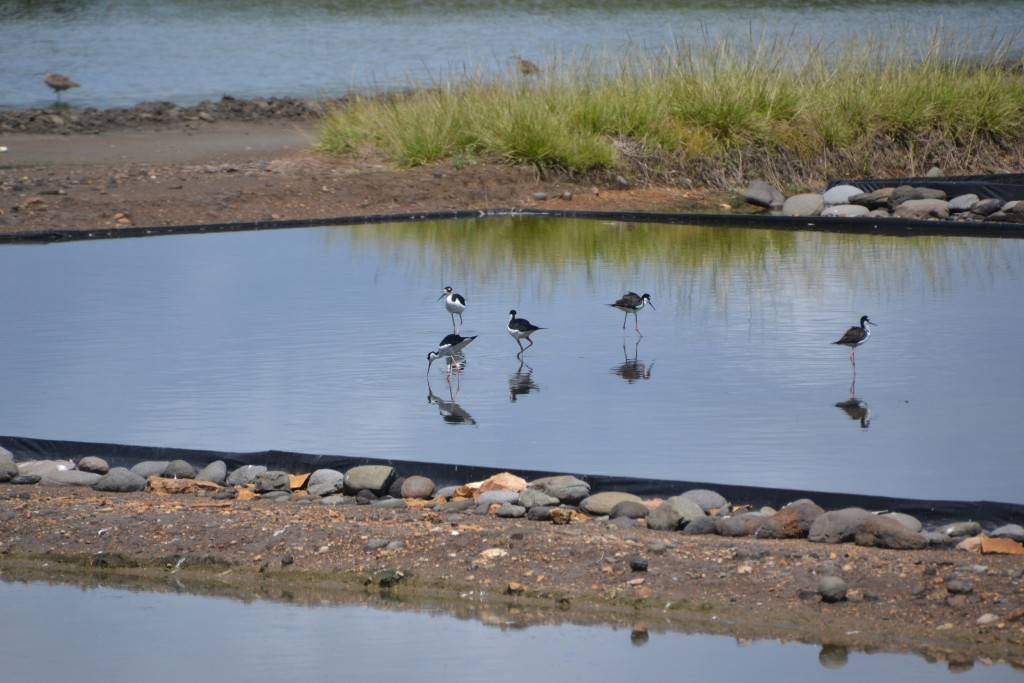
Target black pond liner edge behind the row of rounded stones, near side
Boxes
[0,436,1024,530]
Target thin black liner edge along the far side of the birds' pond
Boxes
[0,209,1024,244]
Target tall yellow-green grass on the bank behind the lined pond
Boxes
[318,31,1024,188]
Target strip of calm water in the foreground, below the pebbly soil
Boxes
[0,582,1019,683]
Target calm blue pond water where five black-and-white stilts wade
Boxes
[0,218,1024,503]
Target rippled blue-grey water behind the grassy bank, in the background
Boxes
[0,0,1024,109]
